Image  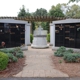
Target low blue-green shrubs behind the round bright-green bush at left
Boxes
[1,47,24,62]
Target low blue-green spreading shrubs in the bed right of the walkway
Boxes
[54,46,80,62]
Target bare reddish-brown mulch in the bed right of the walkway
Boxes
[51,56,80,77]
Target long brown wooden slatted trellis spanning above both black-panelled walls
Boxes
[0,16,80,33]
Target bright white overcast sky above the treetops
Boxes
[0,0,80,17]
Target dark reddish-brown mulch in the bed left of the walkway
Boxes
[0,57,25,77]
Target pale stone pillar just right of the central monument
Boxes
[50,23,55,45]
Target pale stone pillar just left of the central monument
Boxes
[25,23,31,45]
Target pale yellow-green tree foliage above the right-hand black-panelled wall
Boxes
[51,3,80,17]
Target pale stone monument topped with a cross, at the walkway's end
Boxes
[31,26,49,49]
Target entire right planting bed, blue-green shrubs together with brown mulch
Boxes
[51,46,80,77]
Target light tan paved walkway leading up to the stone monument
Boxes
[14,47,68,77]
